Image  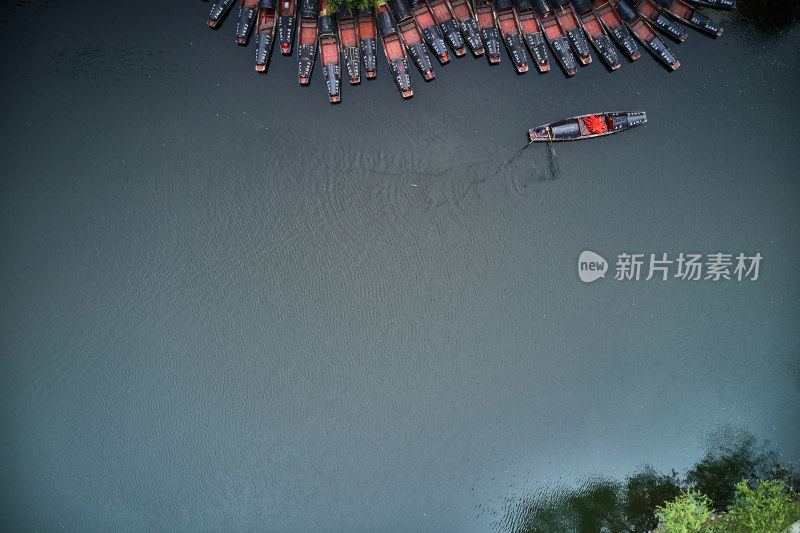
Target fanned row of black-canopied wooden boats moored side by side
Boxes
[208,0,736,103]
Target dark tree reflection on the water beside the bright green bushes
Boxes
[497,427,798,533]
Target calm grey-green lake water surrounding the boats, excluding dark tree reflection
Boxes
[0,0,800,532]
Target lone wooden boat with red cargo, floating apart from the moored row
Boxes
[528,111,647,142]
